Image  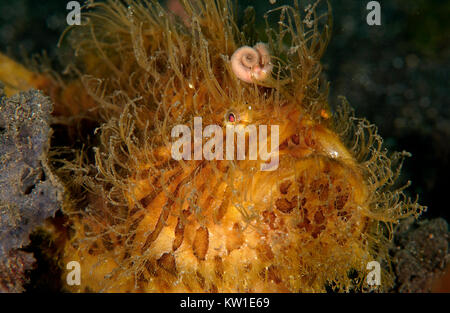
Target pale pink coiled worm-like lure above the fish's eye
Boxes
[231,42,273,83]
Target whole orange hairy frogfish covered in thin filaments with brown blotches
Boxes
[2,0,422,292]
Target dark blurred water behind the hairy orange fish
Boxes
[0,0,450,220]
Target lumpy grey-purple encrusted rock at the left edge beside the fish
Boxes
[0,86,63,292]
